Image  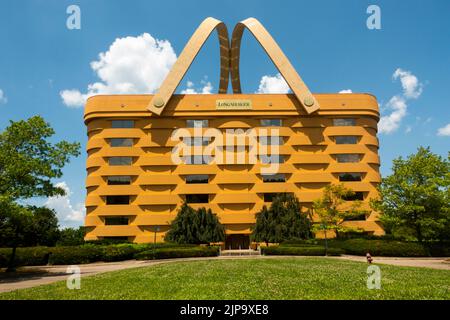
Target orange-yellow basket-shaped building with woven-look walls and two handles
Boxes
[84,16,383,248]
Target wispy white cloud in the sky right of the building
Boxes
[378,68,423,134]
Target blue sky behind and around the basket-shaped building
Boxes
[0,0,450,229]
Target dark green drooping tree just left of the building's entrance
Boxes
[166,203,225,244]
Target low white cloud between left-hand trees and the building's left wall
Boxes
[44,181,85,227]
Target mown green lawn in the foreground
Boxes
[0,257,450,300]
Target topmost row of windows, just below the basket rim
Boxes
[111,118,356,129]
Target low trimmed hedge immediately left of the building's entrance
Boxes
[134,247,219,260]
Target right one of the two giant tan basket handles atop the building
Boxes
[231,18,320,114]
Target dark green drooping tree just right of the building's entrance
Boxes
[251,193,312,244]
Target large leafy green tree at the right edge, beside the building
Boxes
[372,147,450,242]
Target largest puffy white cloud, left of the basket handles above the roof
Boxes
[60,33,177,107]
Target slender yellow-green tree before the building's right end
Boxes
[313,184,364,252]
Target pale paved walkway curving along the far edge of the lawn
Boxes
[0,255,450,293]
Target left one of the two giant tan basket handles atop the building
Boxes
[147,17,230,115]
